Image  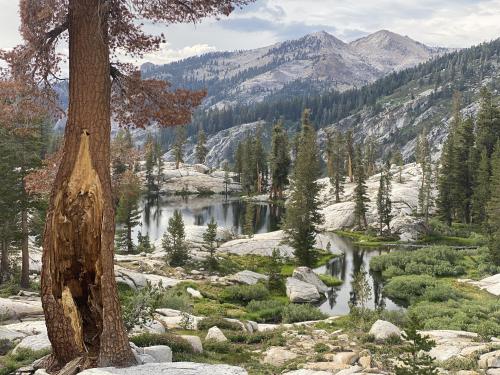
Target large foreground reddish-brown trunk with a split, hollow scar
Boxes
[41,0,135,371]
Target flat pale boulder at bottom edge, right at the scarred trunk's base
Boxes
[80,362,248,375]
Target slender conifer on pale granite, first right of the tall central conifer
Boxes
[327,132,346,203]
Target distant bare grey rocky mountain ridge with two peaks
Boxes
[142,30,449,108]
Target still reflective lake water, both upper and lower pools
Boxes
[136,196,401,315]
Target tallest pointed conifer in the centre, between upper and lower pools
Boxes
[284,110,323,267]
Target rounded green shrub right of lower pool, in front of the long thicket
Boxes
[384,275,463,303]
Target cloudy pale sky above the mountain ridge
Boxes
[0,0,500,63]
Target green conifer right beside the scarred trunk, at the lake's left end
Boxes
[116,170,141,253]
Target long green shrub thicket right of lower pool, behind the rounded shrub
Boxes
[370,246,465,278]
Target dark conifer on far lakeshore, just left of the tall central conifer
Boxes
[269,120,292,199]
